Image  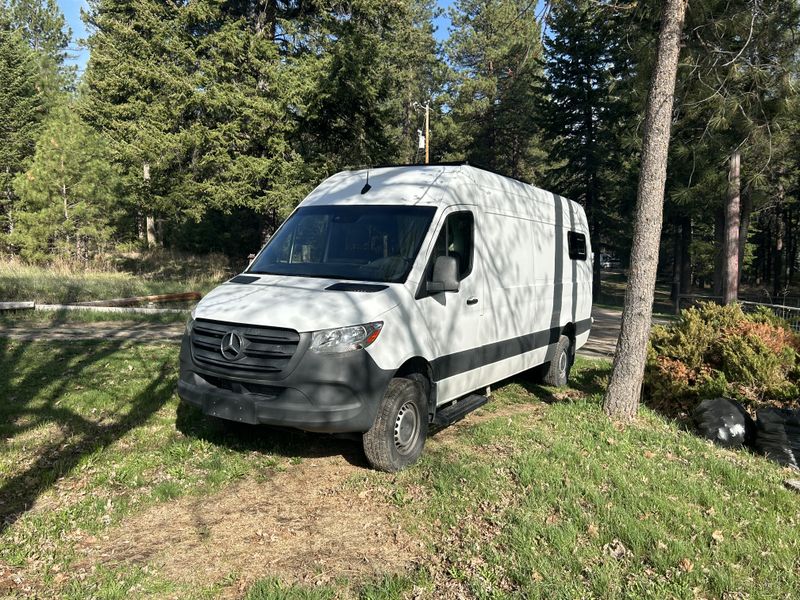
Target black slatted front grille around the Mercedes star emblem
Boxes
[192,319,300,374]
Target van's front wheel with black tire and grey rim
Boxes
[362,377,428,473]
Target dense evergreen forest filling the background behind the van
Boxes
[0,0,800,295]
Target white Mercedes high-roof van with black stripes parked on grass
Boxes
[178,165,592,471]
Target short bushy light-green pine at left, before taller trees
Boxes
[9,106,119,262]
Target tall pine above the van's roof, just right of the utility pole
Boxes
[446,0,547,181]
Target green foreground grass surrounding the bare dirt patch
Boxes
[0,340,800,599]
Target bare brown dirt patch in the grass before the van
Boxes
[79,458,422,590]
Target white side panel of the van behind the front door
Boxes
[438,178,592,404]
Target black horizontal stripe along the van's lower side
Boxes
[431,319,592,381]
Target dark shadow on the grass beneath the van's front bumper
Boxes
[175,402,369,467]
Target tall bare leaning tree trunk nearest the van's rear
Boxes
[603,0,687,420]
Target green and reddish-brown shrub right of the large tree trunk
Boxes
[644,303,800,414]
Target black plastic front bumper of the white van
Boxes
[178,335,392,433]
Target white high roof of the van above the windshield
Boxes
[301,164,585,227]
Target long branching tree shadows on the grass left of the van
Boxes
[0,339,175,533]
